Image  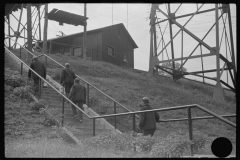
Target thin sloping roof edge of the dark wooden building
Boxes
[40,23,138,48]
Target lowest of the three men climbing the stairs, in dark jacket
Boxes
[68,78,86,123]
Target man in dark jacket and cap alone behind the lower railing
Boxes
[138,97,159,136]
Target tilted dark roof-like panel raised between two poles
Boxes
[48,8,88,26]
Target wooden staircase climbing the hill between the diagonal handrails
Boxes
[5,49,111,139]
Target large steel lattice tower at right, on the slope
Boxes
[149,4,237,100]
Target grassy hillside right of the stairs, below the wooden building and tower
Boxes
[39,55,236,142]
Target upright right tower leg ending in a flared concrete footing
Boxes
[213,4,225,101]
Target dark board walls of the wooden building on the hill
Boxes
[48,26,134,68]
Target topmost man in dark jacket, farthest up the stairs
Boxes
[28,56,46,92]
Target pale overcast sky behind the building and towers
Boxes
[5,3,237,89]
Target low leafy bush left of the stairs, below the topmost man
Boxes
[13,86,33,101]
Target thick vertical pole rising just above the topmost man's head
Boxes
[27,4,32,62]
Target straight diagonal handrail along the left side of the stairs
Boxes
[4,47,91,118]
